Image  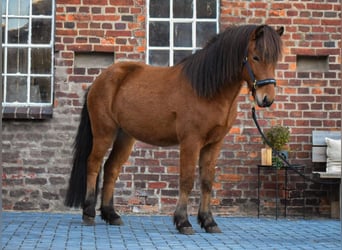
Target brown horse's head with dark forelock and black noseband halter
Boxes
[243,25,284,107]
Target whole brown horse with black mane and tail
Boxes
[65,25,283,234]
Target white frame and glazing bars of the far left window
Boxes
[2,0,56,107]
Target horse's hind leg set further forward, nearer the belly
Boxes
[101,129,135,225]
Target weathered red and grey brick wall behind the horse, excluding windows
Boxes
[3,0,341,216]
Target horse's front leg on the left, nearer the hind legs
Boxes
[173,141,200,234]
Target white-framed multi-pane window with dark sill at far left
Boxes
[2,0,55,118]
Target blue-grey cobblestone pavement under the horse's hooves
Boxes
[2,212,341,250]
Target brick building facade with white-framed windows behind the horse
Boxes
[2,0,342,216]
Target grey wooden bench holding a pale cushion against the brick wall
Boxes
[312,131,341,219]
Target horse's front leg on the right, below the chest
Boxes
[198,141,222,233]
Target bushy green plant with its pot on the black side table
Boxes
[264,125,290,168]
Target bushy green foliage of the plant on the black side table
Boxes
[264,125,290,151]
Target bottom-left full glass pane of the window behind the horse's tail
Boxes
[6,76,27,102]
